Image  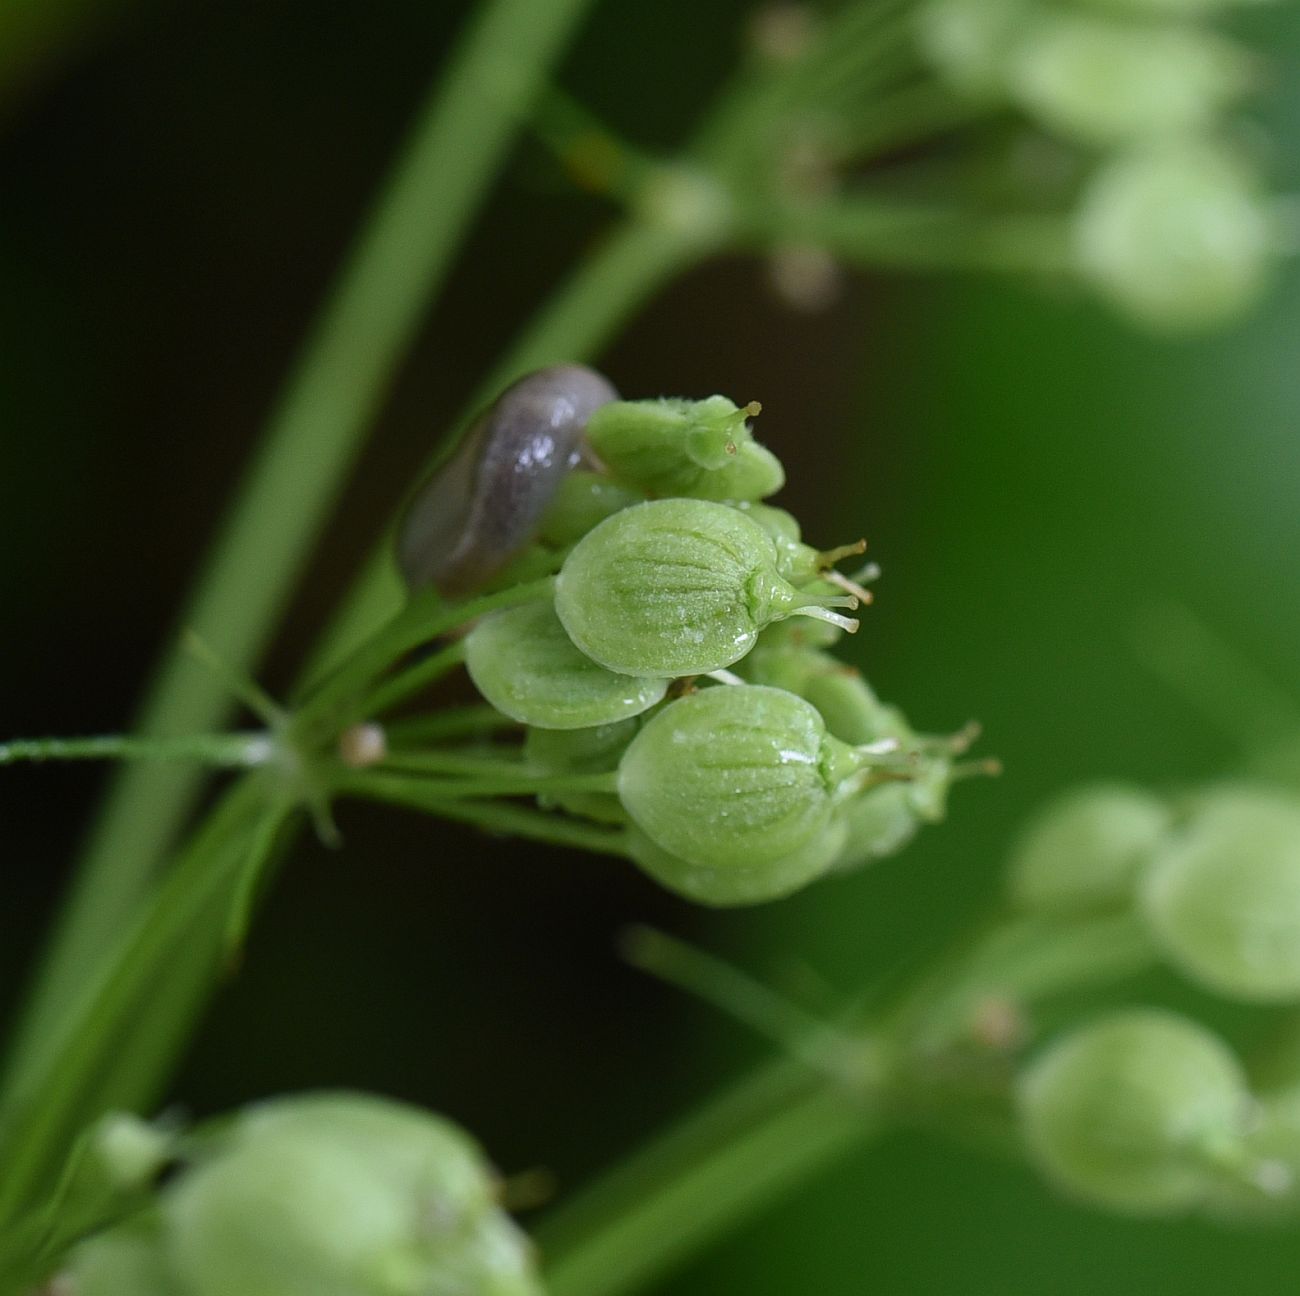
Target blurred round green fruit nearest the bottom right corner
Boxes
[1018,1009,1251,1215]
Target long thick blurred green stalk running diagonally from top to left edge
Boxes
[9,0,600,1102]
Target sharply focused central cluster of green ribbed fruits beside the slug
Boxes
[441,396,972,905]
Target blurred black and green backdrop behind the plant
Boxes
[0,0,1300,1296]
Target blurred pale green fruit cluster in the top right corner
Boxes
[918,0,1282,330]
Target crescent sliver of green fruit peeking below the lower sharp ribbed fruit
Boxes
[628,818,846,909]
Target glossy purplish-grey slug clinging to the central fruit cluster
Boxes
[398,364,619,597]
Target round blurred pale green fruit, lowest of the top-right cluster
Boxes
[1074,142,1273,330]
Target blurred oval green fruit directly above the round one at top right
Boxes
[1008,12,1251,144]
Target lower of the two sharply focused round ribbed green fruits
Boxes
[619,684,872,871]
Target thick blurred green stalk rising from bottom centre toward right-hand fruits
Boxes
[537,915,1156,1296]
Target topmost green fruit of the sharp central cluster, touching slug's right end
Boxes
[586,396,785,499]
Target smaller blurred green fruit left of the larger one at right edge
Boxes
[1008,784,1170,914]
